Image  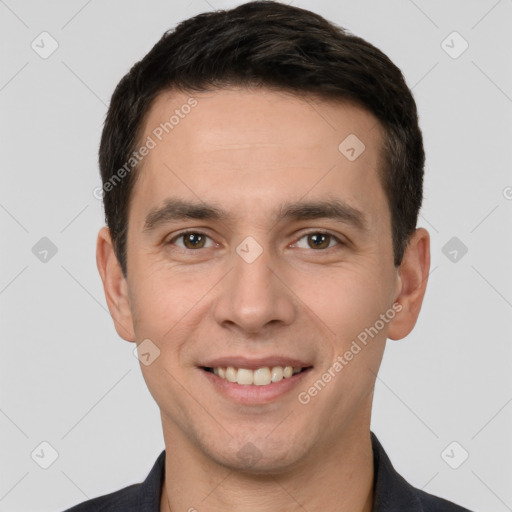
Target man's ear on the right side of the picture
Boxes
[388,228,430,340]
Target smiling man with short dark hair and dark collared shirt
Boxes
[64,2,472,512]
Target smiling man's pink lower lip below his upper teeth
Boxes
[199,364,313,405]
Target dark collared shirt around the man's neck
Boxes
[65,433,469,512]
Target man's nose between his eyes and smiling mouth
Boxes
[213,241,296,334]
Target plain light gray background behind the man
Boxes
[0,0,512,512]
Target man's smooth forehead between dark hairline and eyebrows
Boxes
[131,88,387,230]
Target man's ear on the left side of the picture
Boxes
[96,226,136,341]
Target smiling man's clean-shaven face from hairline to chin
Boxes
[99,89,425,471]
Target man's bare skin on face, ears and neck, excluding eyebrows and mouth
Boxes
[97,88,430,512]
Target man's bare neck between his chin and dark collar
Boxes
[160,418,374,512]
